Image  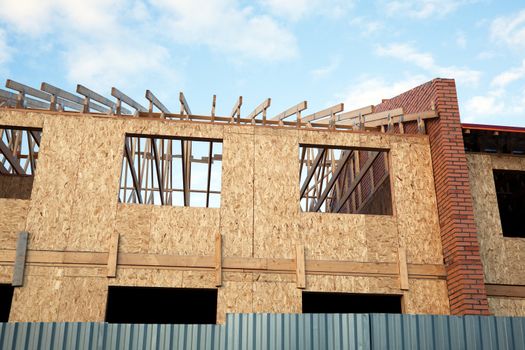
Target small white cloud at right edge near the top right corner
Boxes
[490,9,525,47]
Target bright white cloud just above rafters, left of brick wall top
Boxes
[337,75,428,110]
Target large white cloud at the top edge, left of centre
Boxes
[154,0,298,61]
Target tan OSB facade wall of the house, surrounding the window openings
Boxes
[0,112,448,321]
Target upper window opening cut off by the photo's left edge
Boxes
[0,126,42,199]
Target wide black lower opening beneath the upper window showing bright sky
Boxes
[106,287,217,324]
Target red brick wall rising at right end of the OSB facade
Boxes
[376,79,489,315]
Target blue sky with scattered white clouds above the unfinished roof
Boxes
[0,0,525,126]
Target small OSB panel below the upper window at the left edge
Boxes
[0,198,30,249]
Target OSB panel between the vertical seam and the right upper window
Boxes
[253,129,300,258]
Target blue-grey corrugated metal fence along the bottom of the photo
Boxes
[0,314,525,350]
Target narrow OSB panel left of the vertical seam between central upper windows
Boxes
[220,127,254,257]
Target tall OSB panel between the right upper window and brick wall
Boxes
[390,143,443,264]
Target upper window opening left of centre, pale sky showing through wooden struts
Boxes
[119,135,222,208]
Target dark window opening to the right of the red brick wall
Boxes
[494,170,525,238]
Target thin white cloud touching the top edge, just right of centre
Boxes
[260,0,354,21]
